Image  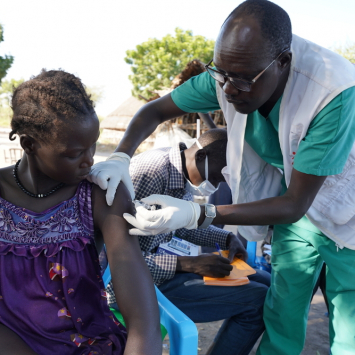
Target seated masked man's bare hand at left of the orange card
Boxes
[176,254,233,277]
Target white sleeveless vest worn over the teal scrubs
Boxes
[216,35,355,249]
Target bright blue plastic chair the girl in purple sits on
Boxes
[102,265,198,355]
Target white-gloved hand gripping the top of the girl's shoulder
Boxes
[87,152,134,206]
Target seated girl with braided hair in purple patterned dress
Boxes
[0,70,162,355]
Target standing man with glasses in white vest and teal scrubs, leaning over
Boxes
[91,0,355,355]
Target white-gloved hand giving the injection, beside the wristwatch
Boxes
[123,195,201,235]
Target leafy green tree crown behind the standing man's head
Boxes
[125,28,214,98]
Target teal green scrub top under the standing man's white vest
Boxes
[171,72,355,234]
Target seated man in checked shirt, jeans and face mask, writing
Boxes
[103,129,270,354]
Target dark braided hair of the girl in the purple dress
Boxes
[9,69,95,141]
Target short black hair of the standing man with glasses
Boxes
[226,0,292,59]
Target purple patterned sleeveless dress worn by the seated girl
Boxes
[0,180,127,355]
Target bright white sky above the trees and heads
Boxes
[0,0,355,116]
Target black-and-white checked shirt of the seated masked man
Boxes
[107,143,230,304]
